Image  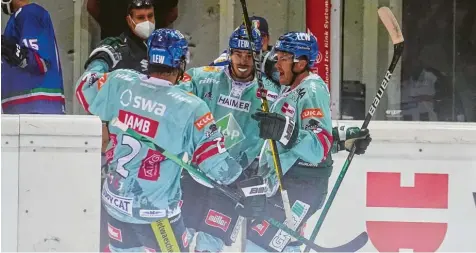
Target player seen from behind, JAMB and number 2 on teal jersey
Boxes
[76,29,266,252]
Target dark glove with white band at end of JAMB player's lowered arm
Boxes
[235,176,267,218]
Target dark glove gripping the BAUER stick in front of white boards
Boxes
[332,126,372,155]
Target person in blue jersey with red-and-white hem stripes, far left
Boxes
[1,0,65,114]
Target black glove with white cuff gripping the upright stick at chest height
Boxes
[251,111,299,148]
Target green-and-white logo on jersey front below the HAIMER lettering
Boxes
[216,113,246,149]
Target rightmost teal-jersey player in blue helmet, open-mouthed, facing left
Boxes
[246,32,333,252]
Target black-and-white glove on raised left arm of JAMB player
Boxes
[84,37,125,71]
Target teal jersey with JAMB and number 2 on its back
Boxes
[76,60,242,224]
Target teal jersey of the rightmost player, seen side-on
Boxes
[259,74,333,176]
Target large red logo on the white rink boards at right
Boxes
[366,172,448,252]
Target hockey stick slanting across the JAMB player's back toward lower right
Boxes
[110,118,360,252]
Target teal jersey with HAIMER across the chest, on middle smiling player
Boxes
[178,65,278,168]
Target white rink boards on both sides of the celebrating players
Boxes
[1,115,476,252]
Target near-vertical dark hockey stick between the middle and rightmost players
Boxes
[240,0,293,227]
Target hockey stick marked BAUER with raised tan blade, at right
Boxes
[304,7,404,252]
